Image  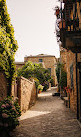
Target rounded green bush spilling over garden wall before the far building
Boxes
[17,61,51,90]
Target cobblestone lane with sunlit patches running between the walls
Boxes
[12,89,81,137]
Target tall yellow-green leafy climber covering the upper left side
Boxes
[0,0,18,95]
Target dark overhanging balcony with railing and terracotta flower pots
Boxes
[59,0,81,53]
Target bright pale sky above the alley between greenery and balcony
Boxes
[6,0,59,61]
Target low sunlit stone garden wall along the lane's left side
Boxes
[17,77,37,112]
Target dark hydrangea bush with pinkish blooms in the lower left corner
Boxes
[0,97,21,133]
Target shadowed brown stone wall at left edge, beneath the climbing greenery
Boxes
[0,71,7,100]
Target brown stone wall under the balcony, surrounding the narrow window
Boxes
[61,50,77,113]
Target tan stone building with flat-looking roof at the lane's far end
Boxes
[24,54,57,85]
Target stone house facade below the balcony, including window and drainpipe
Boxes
[60,47,81,121]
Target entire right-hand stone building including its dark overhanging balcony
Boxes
[56,0,81,122]
